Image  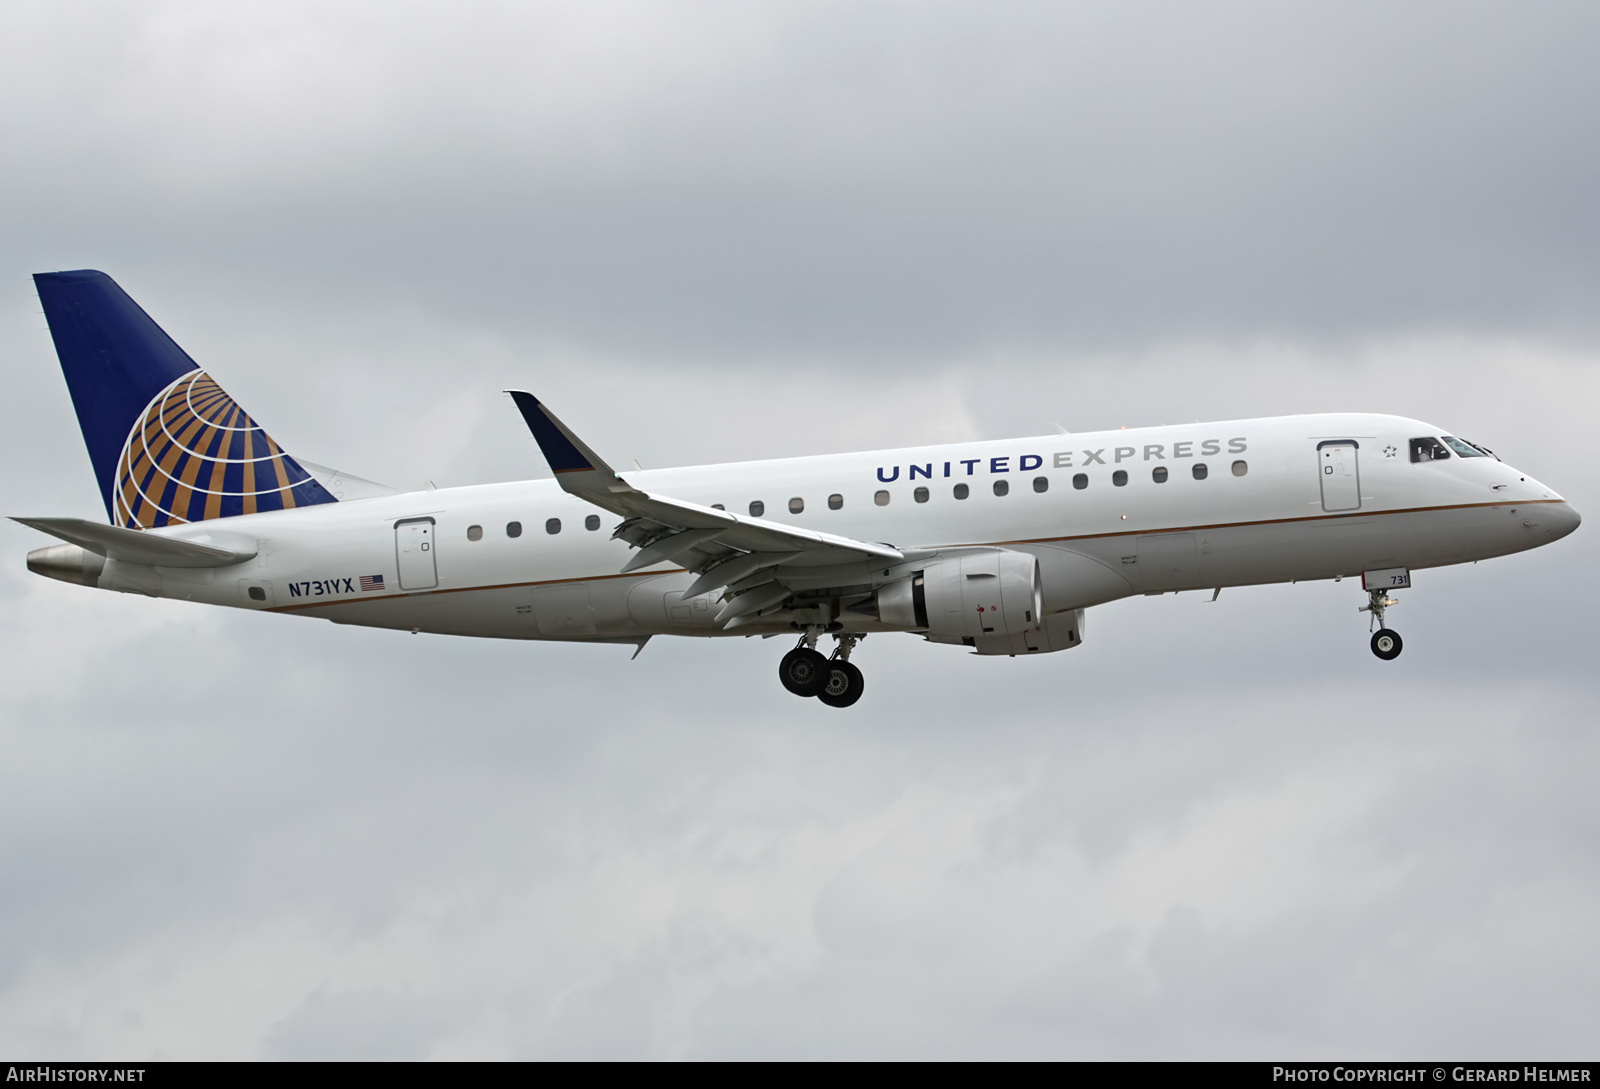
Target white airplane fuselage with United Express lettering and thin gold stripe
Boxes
[99,414,1579,643]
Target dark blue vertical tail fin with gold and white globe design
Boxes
[34,269,334,529]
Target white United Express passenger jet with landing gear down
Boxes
[16,270,1581,707]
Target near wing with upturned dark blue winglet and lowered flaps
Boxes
[507,390,906,610]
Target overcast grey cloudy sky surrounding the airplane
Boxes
[0,2,1600,1059]
